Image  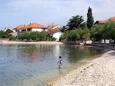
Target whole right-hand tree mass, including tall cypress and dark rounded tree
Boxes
[61,7,115,42]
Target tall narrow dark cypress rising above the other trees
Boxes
[87,7,94,28]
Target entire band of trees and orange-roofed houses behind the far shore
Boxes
[0,7,115,43]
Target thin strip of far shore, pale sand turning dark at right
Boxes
[0,39,115,51]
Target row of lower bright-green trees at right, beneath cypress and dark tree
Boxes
[61,22,115,41]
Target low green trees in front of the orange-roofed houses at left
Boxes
[0,29,55,41]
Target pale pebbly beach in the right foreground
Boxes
[46,50,115,86]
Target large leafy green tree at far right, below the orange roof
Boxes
[91,22,115,41]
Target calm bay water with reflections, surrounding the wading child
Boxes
[0,45,102,86]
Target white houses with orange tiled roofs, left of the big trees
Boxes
[14,23,62,41]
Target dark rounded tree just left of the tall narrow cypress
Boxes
[67,15,84,30]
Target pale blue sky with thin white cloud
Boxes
[0,0,115,28]
